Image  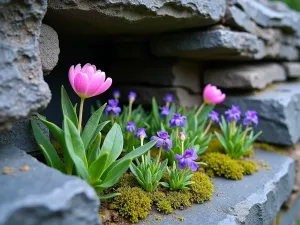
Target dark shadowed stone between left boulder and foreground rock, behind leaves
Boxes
[0,117,49,153]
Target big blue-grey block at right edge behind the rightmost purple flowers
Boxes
[217,82,300,145]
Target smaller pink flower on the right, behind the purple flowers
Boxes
[203,84,226,105]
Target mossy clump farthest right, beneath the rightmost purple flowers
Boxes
[200,152,244,180]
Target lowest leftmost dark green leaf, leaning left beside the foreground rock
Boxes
[31,119,65,173]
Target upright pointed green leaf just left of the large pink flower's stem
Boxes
[61,86,78,127]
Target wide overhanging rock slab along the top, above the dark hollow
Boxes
[45,0,226,36]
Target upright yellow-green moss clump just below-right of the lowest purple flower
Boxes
[190,172,214,204]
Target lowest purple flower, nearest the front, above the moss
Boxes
[174,148,198,172]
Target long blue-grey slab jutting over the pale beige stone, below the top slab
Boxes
[151,29,265,60]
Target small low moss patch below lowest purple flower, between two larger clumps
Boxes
[167,191,192,209]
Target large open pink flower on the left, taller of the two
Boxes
[69,63,112,98]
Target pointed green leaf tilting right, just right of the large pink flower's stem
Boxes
[81,104,106,149]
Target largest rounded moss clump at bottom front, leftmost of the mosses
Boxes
[110,187,151,223]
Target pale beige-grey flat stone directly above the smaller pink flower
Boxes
[204,63,286,89]
